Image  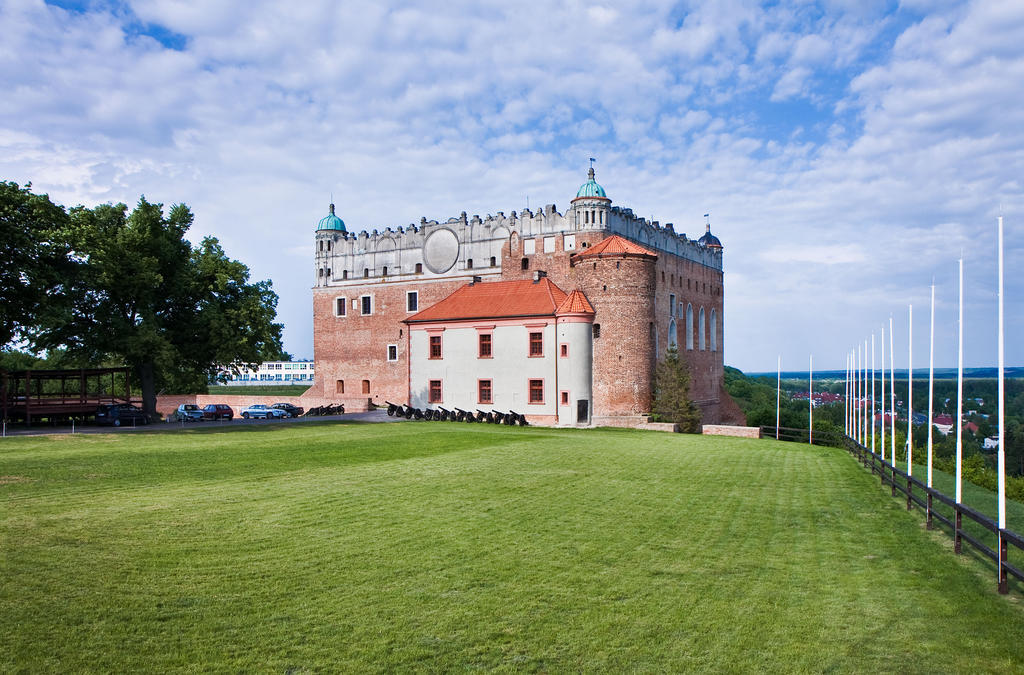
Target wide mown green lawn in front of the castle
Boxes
[0,423,1024,673]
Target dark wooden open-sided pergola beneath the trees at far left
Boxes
[0,367,131,425]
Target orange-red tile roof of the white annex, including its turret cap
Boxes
[406,278,569,324]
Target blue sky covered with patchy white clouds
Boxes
[0,0,1024,371]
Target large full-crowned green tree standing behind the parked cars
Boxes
[33,197,282,413]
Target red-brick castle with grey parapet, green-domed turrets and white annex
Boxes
[309,168,735,425]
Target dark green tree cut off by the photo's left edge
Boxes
[0,181,72,347]
